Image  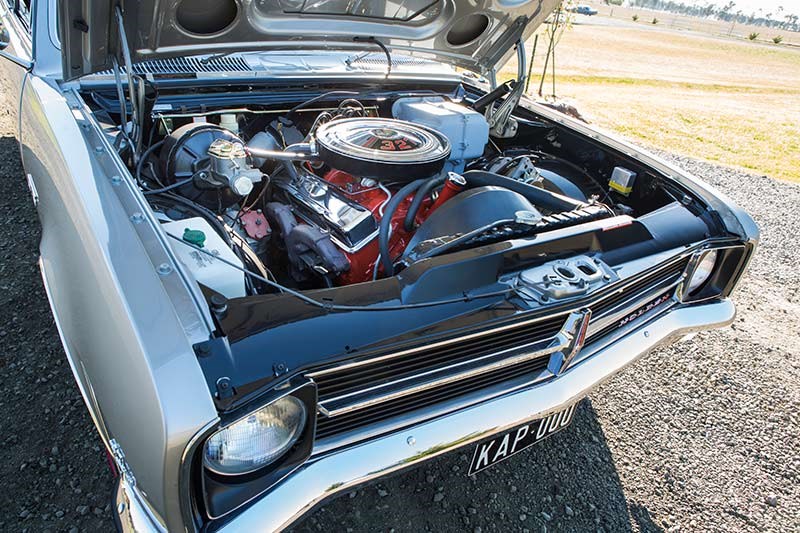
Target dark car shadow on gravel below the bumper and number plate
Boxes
[294,399,663,533]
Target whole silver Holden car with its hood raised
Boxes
[0,0,758,532]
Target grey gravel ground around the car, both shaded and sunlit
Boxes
[0,85,800,532]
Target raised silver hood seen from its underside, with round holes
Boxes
[59,0,559,80]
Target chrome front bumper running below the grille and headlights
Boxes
[117,299,736,531]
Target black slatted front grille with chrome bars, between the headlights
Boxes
[310,257,688,439]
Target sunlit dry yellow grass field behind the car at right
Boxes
[501,15,800,181]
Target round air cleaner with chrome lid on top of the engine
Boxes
[315,118,450,181]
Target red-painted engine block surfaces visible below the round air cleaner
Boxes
[325,170,432,285]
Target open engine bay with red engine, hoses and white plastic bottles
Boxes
[90,85,692,298]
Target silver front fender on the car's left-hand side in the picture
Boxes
[21,76,217,530]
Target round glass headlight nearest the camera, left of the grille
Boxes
[203,396,307,475]
